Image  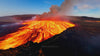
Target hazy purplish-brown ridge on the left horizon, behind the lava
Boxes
[0,14,37,25]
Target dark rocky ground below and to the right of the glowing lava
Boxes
[0,17,100,56]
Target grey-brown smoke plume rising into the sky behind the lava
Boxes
[41,0,75,17]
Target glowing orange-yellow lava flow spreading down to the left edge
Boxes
[0,16,75,50]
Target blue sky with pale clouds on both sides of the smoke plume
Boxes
[0,0,100,18]
